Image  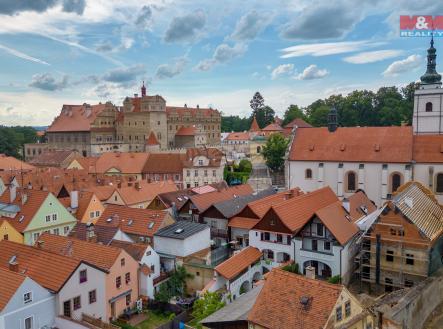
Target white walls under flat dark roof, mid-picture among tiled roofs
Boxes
[154,227,211,257]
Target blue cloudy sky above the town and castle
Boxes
[0,0,443,126]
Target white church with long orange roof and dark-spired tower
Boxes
[285,39,443,206]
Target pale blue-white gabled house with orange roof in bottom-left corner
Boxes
[0,268,55,329]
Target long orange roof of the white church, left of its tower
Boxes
[289,126,412,163]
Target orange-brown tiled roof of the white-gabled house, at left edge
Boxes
[0,240,80,292]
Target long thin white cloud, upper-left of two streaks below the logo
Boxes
[280,40,384,58]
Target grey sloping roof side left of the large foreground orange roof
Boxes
[201,284,263,326]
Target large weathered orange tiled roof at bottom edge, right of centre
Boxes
[248,269,343,329]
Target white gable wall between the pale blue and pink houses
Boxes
[57,263,108,321]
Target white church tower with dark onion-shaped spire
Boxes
[412,38,443,135]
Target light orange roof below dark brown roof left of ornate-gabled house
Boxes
[117,181,177,205]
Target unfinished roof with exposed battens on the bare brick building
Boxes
[393,182,443,241]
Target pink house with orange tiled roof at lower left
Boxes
[37,233,139,321]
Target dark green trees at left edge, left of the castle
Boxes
[0,126,37,158]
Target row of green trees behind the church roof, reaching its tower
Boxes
[221,82,418,132]
